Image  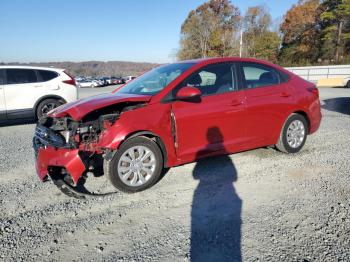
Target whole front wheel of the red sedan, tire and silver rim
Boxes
[107,136,163,193]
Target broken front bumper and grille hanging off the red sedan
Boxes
[33,124,114,199]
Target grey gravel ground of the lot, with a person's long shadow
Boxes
[0,88,350,261]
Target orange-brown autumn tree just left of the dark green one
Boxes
[279,0,320,65]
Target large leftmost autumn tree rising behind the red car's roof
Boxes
[178,0,240,60]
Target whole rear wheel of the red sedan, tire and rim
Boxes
[276,114,308,153]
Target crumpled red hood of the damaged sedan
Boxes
[49,93,152,121]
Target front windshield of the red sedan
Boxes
[116,63,194,95]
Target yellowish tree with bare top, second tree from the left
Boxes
[243,6,280,62]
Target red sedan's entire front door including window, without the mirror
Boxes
[172,63,245,162]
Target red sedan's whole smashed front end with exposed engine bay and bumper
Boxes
[33,102,145,198]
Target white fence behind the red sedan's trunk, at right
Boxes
[286,65,350,83]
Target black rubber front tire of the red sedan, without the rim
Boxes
[104,136,163,193]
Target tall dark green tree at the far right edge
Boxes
[319,0,350,62]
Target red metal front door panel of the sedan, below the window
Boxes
[172,91,246,162]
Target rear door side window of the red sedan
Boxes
[242,63,281,89]
